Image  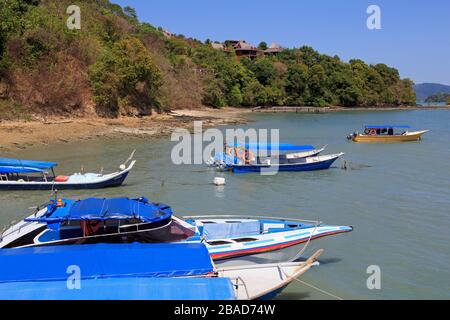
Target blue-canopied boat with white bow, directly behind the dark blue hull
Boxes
[207,143,327,170]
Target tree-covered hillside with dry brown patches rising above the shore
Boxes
[0,0,415,118]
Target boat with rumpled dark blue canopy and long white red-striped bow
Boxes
[0,198,353,263]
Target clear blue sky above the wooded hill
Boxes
[112,0,450,85]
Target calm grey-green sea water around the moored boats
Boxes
[0,110,450,299]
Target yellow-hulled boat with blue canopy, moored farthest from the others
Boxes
[347,125,429,142]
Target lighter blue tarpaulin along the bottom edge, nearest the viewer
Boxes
[0,278,235,300]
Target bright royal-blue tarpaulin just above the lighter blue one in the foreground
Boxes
[0,243,214,283]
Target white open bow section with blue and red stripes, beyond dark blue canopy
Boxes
[183,215,353,265]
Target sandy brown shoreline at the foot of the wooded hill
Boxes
[0,108,250,153]
